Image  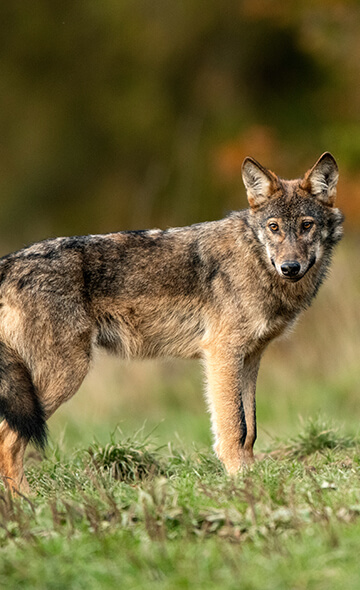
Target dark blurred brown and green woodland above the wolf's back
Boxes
[0,0,360,250]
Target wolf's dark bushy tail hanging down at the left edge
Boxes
[0,341,47,449]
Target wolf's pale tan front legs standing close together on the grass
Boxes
[206,345,261,474]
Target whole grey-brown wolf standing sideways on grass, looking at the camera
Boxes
[0,152,343,493]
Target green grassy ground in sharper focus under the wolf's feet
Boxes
[0,420,360,590]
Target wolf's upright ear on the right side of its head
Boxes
[301,152,339,207]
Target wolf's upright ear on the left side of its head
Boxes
[241,158,278,209]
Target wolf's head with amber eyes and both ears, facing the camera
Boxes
[242,152,343,282]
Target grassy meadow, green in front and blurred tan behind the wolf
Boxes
[0,237,360,590]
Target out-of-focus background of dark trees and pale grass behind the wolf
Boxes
[0,0,360,454]
